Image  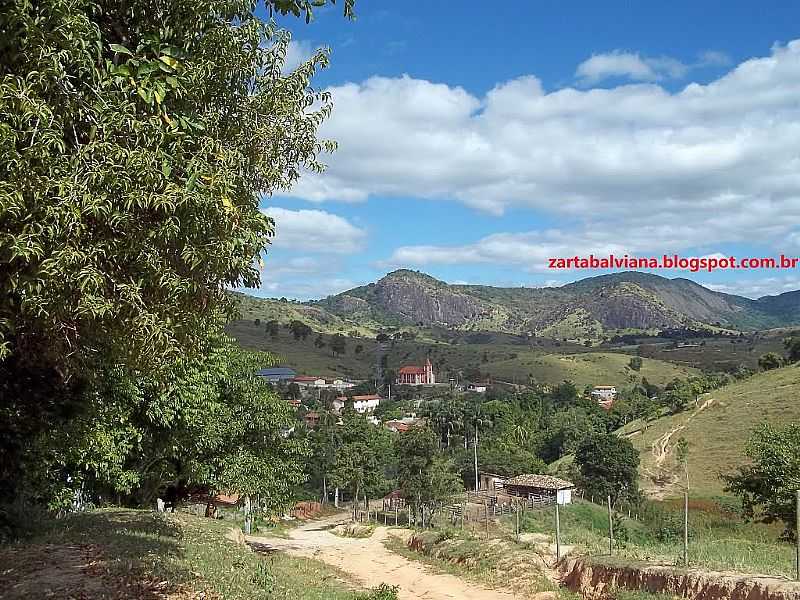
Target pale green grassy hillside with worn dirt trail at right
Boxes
[623,365,800,495]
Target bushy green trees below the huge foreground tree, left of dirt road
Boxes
[23,340,307,510]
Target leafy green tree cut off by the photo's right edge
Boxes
[725,424,800,536]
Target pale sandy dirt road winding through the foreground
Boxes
[247,515,522,600]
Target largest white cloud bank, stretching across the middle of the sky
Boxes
[292,41,800,251]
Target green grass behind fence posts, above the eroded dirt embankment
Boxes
[509,500,794,576]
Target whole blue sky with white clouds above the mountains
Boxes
[257,0,800,299]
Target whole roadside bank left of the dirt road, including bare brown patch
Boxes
[0,509,396,600]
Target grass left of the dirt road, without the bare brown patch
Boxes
[0,509,391,600]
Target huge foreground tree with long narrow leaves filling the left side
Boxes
[0,0,352,498]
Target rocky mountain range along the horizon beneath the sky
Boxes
[241,269,800,340]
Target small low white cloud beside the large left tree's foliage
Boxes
[263,206,366,254]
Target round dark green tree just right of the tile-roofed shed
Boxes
[575,433,639,504]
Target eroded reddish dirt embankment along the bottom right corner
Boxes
[560,559,800,600]
